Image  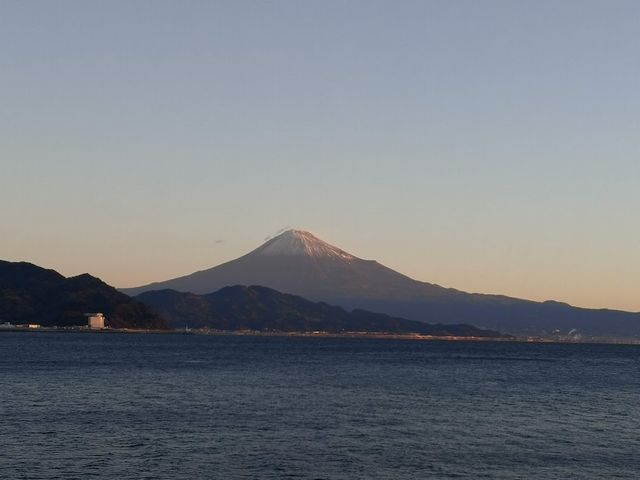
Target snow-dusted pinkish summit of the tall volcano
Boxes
[250,230,356,262]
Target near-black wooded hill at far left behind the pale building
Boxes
[0,261,166,329]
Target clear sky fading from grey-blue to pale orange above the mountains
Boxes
[0,0,640,311]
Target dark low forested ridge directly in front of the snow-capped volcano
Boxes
[136,286,501,337]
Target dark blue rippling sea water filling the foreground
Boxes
[0,333,640,480]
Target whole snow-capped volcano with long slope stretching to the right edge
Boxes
[121,230,640,337]
